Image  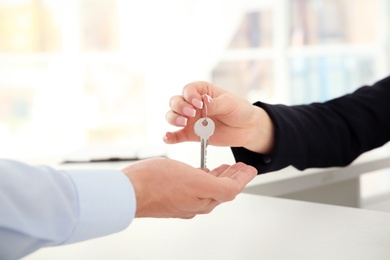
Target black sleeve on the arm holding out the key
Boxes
[232,77,390,174]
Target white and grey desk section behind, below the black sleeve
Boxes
[244,154,390,207]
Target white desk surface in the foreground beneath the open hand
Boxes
[25,194,390,260]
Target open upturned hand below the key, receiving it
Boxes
[122,158,257,219]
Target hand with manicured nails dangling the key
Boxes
[164,81,275,154]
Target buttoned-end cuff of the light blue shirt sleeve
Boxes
[65,169,136,244]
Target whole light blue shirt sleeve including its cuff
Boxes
[0,160,136,259]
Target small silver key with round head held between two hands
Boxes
[194,117,215,169]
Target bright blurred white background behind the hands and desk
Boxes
[0,0,390,173]
